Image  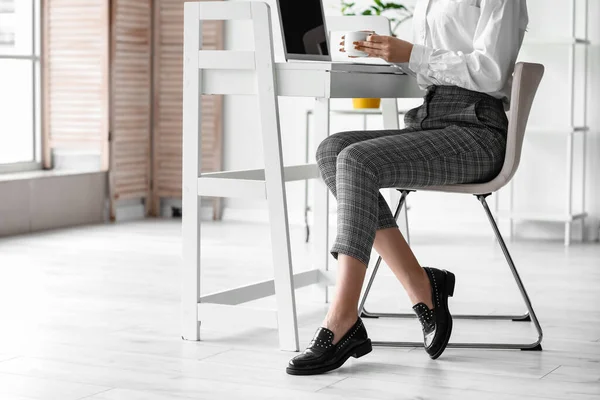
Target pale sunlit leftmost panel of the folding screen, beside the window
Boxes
[42,0,109,170]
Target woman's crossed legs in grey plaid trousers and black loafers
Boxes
[286,127,504,375]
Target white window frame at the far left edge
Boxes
[0,0,44,174]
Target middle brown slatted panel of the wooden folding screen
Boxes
[109,0,153,218]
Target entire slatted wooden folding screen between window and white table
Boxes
[42,0,223,218]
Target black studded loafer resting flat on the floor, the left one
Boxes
[286,318,373,375]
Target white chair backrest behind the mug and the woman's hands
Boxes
[325,15,392,64]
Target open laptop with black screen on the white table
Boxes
[277,0,403,74]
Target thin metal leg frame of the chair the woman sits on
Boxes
[359,191,543,350]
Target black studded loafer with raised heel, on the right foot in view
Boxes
[413,267,456,360]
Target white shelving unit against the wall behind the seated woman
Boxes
[496,0,590,246]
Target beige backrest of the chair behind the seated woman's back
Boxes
[492,62,544,190]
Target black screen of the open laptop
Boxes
[278,0,331,60]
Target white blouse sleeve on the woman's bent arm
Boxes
[408,0,528,93]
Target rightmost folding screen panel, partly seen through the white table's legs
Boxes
[152,0,223,218]
